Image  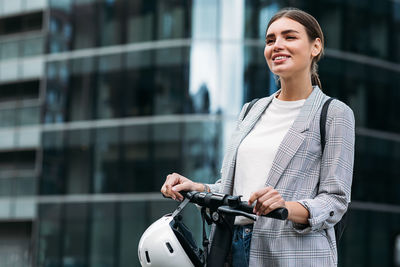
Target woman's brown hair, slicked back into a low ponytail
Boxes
[267,7,324,88]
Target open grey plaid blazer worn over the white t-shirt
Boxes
[210,86,355,267]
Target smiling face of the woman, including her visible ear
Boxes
[264,17,321,78]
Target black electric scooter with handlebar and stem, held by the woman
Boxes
[162,191,288,267]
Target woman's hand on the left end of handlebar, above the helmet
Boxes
[161,173,204,201]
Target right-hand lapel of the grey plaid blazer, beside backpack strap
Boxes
[266,86,324,188]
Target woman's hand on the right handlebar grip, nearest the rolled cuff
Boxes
[249,186,286,215]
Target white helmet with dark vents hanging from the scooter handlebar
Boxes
[138,214,203,267]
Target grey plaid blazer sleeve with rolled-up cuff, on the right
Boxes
[293,100,355,233]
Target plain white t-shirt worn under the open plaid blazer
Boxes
[233,96,306,225]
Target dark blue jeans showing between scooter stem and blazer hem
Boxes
[231,224,253,267]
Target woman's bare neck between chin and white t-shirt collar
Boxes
[278,71,313,101]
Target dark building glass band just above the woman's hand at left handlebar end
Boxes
[40,121,222,194]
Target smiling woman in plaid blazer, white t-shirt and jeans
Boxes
[161,8,354,266]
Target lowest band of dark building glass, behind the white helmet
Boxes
[33,202,184,266]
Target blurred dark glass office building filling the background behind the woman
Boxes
[0,0,400,267]
